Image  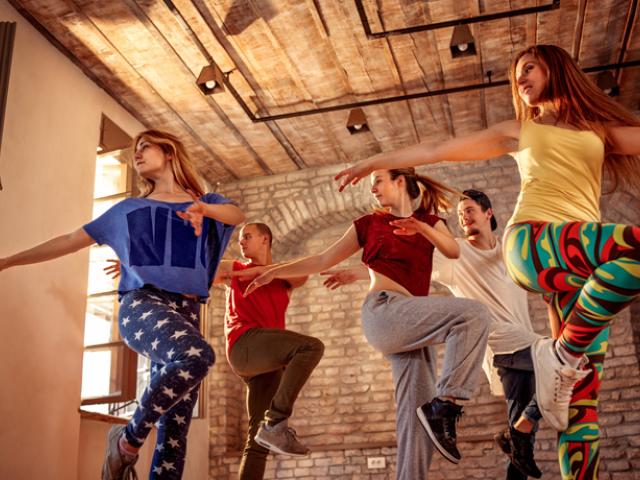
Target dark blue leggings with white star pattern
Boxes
[119,286,215,480]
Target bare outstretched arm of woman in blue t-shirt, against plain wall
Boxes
[0,228,96,271]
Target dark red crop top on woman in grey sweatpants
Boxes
[353,208,442,296]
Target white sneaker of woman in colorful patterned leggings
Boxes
[531,338,589,432]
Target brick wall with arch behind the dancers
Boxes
[209,158,640,480]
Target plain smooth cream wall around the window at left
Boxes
[0,0,207,480]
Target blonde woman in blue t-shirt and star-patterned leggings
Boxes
[0,130,244,480]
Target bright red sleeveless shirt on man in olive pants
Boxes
[224,261,291,355]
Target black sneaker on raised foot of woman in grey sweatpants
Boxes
[416,398,462,463]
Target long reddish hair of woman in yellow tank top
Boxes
[509,45,640,191]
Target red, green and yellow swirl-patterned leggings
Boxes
[503,222,640,480]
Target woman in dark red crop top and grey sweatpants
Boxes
[241,168,489,480]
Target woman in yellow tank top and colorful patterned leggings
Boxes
[336,45,640,479]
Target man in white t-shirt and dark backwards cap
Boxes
[325,190,542,480]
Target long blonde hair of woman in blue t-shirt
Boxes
[133,130,205,197]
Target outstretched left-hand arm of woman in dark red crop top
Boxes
[245,225,360,295]
